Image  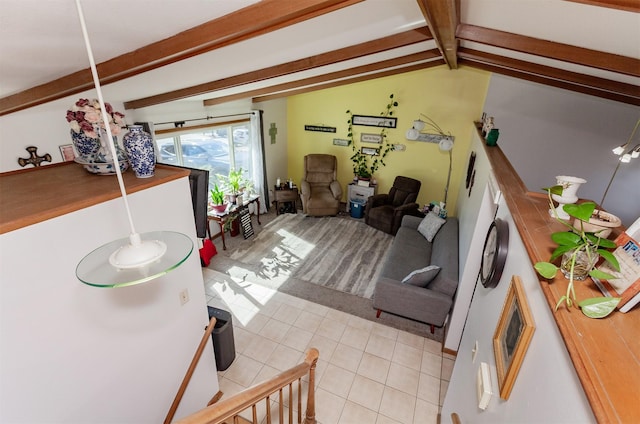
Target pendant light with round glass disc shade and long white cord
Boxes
[76,0,193,287]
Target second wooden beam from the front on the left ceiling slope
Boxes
[124,27,432,109]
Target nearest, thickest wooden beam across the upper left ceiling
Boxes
[0,0,362,116]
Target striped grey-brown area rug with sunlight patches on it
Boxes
[230,214,393,299]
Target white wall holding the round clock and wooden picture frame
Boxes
[442,136,595,423]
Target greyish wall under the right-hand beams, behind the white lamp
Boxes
[485,74,640,226]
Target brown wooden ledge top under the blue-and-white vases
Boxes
[0,162,189,234]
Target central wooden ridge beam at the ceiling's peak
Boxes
[416,0,460,69]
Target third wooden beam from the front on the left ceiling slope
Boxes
[203,49,441,106]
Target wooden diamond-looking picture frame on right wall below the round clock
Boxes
[493,275,536,400]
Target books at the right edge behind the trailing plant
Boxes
[594,218,640,312]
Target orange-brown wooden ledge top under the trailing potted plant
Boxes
[481,126,640,423]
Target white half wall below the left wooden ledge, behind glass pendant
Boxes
[0,177,218,424]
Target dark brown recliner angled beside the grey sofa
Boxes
[364,176,422,236]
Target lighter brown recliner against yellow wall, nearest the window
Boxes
[300,154,342,216]
